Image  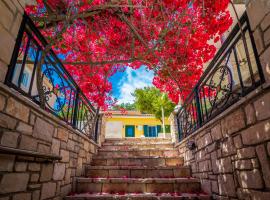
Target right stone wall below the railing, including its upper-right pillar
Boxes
[176,0,270,200]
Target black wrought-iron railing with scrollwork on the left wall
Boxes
[6,15,98,142]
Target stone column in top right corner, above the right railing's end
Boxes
[247,0,270,83]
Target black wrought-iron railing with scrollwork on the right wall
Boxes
[177,13,264,141]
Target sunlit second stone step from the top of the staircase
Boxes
[102,143,174,151]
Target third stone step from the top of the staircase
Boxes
[98,149,179,158]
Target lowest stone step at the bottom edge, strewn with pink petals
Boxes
[65,193,211,200]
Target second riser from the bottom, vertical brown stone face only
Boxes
[86,168,191,178]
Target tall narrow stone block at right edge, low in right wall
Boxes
[256,144,270,189]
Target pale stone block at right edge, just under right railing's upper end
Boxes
[254,92,270,120]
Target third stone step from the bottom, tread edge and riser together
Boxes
[86,166,191,178]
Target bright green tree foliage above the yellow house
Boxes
[134,87,175,121]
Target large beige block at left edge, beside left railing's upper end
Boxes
[0,26,15,64]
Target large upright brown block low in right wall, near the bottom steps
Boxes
[218,174,236,197]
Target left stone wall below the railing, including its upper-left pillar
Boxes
[0,0,104,200]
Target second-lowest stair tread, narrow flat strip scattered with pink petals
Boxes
[76,177,200,184]
